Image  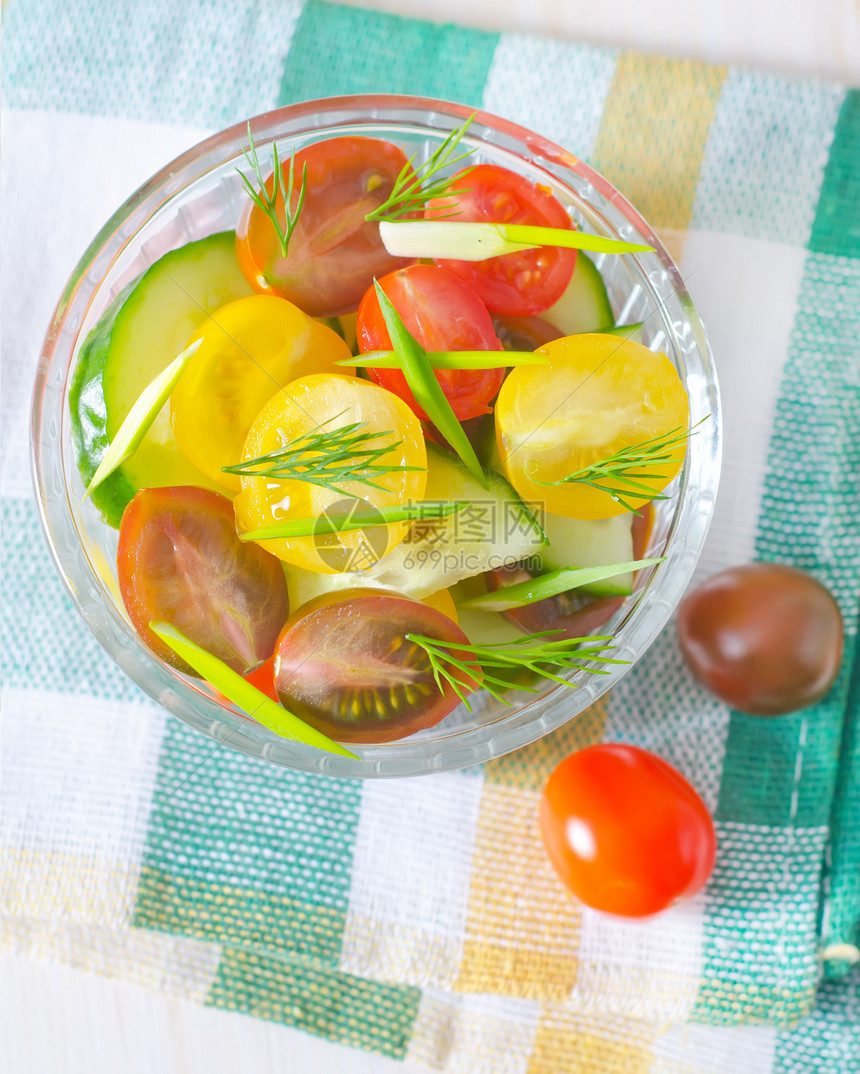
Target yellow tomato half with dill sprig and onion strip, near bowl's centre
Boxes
[234,374,427,575]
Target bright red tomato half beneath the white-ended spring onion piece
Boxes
[425,164,577,316]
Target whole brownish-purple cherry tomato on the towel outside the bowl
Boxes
[677,563,843,716]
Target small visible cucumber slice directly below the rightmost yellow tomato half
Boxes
[540,514,635,597]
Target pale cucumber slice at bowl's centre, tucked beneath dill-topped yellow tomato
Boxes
[285,442,546,609]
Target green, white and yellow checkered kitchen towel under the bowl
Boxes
[2,0,860,1074]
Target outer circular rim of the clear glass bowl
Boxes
[31,95,721,778]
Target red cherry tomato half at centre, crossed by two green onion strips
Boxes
[356,265,505,420]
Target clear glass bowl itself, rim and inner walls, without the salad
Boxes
[32,96,720,778]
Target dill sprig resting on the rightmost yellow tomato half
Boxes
[528,418,708,513]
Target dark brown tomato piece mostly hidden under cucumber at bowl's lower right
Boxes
[485,504,654,638]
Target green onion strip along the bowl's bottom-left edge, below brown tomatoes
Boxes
[149,622,359,760]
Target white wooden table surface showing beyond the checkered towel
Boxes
[0,0,860,1074]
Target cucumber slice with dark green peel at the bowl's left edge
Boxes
[70,231,253,526]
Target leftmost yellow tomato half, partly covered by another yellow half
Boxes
[171,294,351,493]
